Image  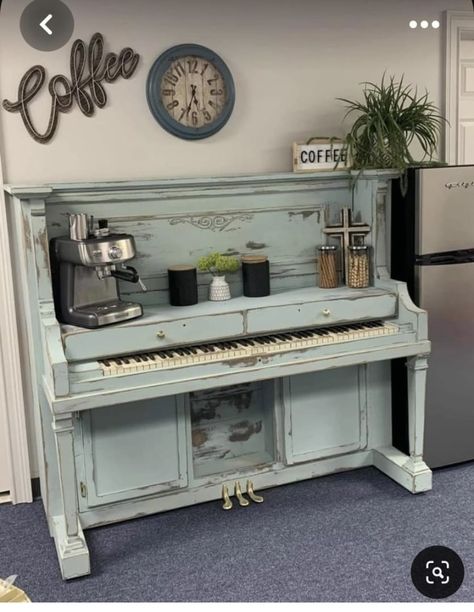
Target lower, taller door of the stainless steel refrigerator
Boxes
[418,260,474,468]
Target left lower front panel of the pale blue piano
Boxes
[75,396,188,509]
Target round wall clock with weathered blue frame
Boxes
[147,44,235,140]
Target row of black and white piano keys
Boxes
[99,321,399,376]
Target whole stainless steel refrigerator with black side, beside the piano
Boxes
[391,166,474,468]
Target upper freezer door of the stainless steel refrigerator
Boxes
[415,166,474,255]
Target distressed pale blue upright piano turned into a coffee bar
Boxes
[6,171,431,579]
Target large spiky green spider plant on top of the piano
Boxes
[337,75,446,192]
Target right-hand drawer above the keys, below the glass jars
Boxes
[247,294,397,334]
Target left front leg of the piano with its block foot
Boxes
[50,413,90,580]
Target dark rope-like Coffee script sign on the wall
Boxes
[3,33,140,143]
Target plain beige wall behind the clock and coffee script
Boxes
[0,0,472,183]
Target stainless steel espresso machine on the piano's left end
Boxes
[50,213,146,328]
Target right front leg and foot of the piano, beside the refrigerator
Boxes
[373,355,432,493]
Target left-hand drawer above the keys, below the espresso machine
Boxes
[63,312,244,361]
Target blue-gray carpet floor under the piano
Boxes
[0,463,474,602]
